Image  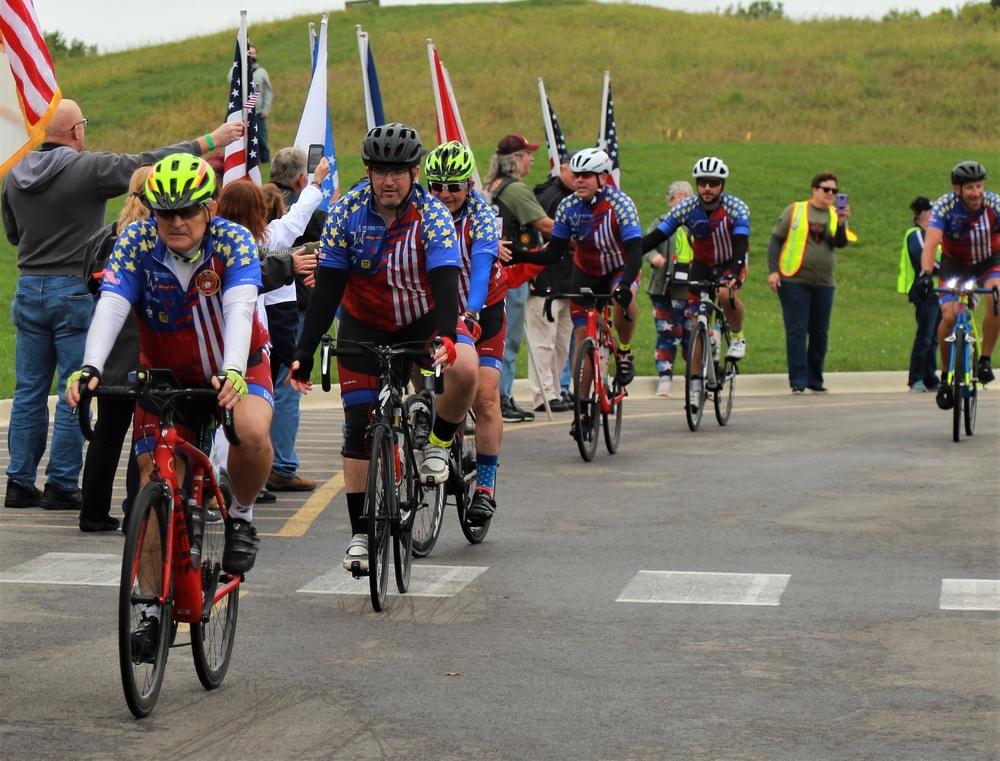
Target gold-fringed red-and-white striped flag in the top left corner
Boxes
[0,0,62,176]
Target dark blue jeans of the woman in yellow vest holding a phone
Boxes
[778,280,835,388]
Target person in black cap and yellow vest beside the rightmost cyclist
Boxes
[897,196,941,392]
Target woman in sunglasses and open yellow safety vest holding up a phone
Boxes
[767,172,851,394]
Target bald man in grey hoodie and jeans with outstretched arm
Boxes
[0,100,243,512]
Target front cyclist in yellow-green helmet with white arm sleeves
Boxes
[66,153,273,574]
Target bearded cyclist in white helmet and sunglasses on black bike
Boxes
[642,156,750,410]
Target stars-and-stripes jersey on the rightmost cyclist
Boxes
[927,190,1000,265]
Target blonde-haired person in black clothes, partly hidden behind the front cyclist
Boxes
[80,166,152,532]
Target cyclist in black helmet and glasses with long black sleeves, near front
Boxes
[291,122,476,570]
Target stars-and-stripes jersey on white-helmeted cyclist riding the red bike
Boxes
[552,185,642,277]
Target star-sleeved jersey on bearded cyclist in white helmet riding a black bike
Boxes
[657,193,750,267]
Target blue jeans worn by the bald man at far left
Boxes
[7,275,94,489]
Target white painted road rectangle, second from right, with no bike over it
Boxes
[616,571,791,605]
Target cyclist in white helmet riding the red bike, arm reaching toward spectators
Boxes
[523,148,642,438]
